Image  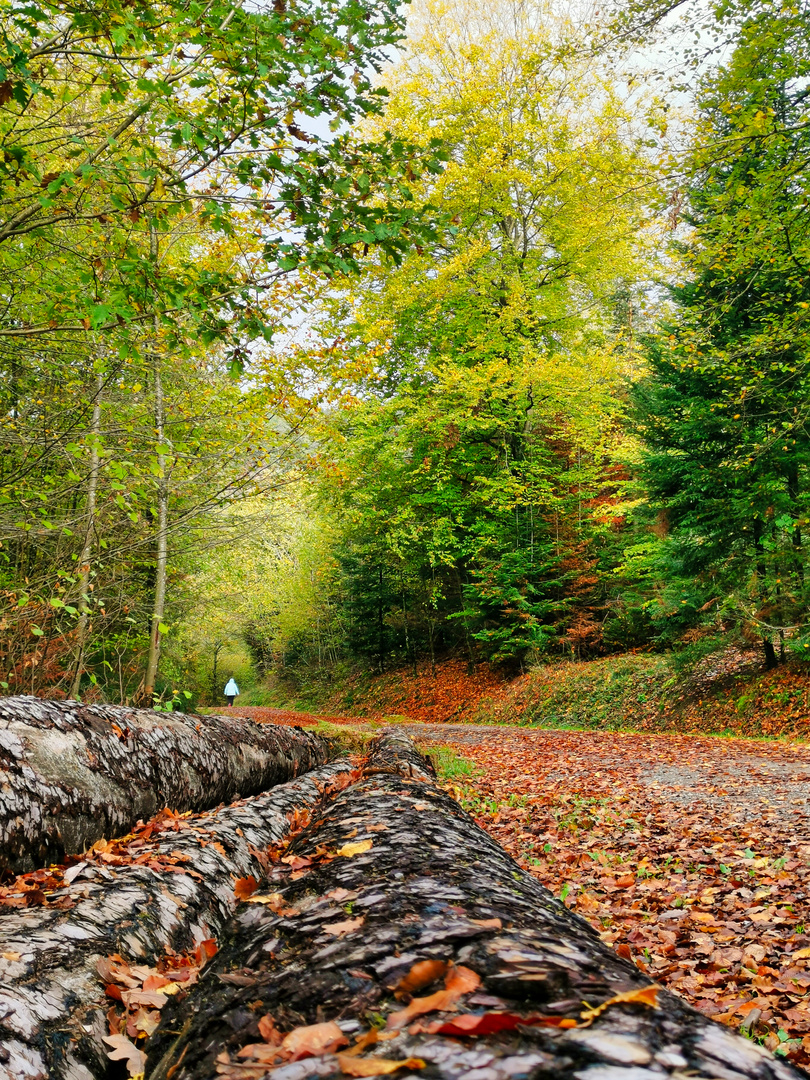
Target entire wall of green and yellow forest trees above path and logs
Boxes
[0,0,810,704]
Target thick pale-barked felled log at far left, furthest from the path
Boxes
[0,697,328,874]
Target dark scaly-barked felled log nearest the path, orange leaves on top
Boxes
[146,737,804,1080]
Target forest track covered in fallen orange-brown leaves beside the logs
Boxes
[219,708,810,1068]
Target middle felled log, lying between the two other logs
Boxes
[0,761,351,1080]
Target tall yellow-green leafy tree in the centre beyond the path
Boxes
[301,2,651,662]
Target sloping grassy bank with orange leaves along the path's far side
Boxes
[284,645,810,740]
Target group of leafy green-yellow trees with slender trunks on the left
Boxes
[0,0,441,702]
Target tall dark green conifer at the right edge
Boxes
[637,8,810,666]
